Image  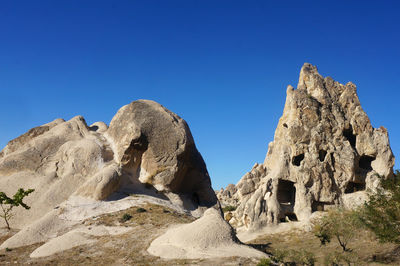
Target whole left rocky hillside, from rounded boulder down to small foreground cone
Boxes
[0,100,266,264]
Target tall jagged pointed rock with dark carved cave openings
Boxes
[218,64,394,229]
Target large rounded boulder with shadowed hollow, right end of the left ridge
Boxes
[106,100,217,206]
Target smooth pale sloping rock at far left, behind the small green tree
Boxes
[0,116,104,228]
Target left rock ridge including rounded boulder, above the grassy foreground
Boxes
[0,100,217,228]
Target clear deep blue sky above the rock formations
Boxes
[0,0,400,189]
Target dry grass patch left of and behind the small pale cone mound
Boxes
[0,204,257,265]
